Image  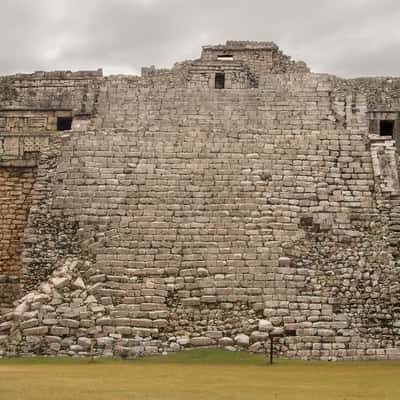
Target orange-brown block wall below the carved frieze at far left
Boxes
[0,167,36,312]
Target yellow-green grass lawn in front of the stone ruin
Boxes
[0,349,400,400]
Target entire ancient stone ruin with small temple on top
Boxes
[0,41,400,360]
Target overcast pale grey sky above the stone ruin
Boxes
[0,0,400,77]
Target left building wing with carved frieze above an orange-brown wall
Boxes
[0,71,102,309]
